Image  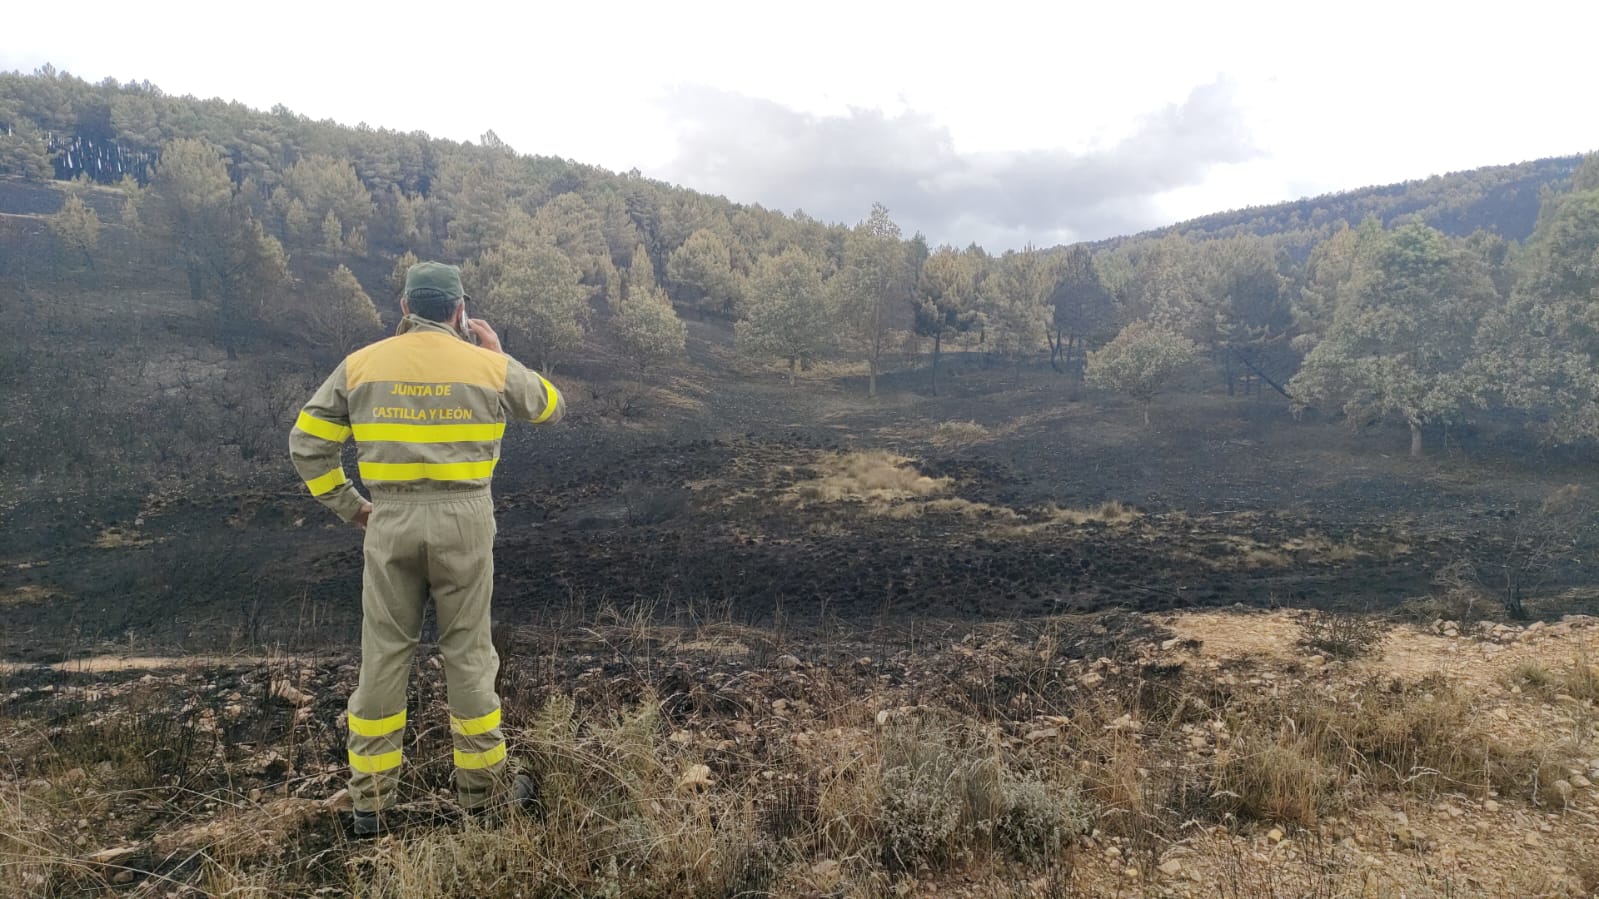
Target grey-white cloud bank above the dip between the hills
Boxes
[659,82,1258,246]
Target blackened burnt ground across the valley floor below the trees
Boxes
[0,371,1586,661]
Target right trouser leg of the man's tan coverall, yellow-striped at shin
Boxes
[427,496,507,808]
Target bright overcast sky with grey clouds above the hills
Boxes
[0,0,1599,248]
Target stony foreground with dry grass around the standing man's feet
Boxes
[0,611,1599,897]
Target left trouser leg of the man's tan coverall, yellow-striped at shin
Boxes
[345,504,427,811]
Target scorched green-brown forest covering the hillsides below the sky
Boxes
[0,67,1599,489]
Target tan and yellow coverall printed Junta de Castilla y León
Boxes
[289,315,566,811]
